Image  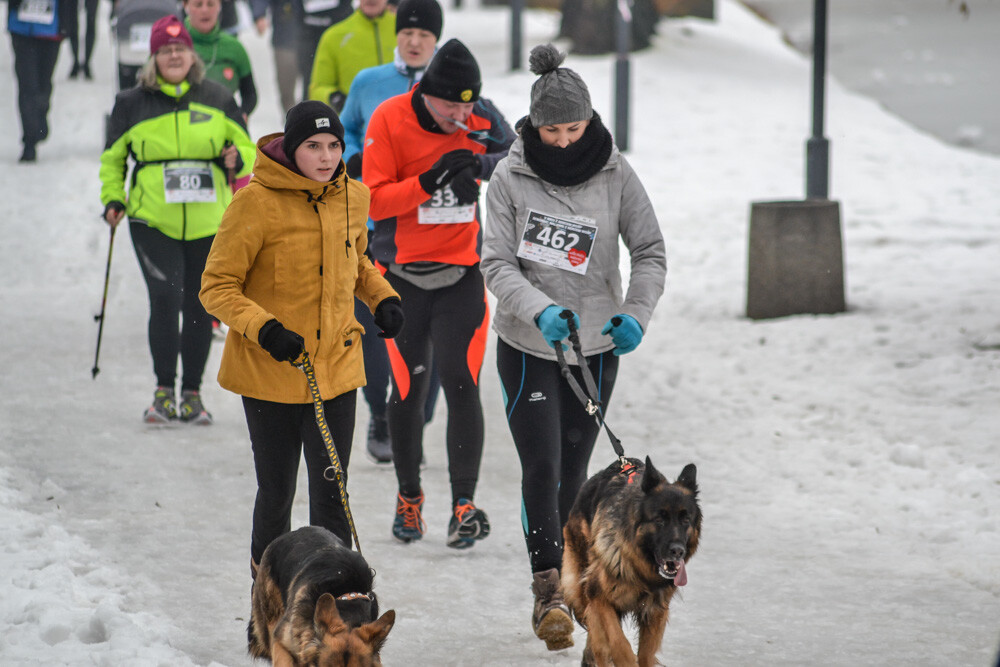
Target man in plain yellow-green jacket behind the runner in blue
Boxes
[309,0,396,113]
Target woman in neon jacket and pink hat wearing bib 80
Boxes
[100,16,254,424]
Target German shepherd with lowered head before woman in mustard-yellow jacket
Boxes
[247,526,396,667]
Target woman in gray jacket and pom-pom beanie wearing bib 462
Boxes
[481,44,667,650]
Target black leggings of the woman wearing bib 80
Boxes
[129,222,215,391]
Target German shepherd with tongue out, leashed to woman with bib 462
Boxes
[562,456,701,667]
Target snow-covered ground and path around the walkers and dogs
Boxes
[0,0,1000,667]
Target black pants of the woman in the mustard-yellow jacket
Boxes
[243,390,357,563]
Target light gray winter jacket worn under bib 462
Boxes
[480,136,667,360]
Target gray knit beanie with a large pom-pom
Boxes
[528,44,594,128]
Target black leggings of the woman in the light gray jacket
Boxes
[497,340,618,572]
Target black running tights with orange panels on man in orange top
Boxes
[385,266,489,503]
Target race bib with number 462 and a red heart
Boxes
[517,210,597,275]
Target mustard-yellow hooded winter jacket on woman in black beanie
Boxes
[200,133,399,403]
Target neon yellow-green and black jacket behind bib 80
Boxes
[100,79,256,241]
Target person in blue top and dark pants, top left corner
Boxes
[7,0,78,162]
